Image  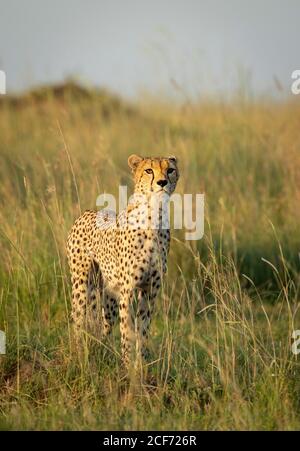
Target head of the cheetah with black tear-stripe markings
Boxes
[128,155,179,195]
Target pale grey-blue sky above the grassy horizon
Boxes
[0,0,300,97]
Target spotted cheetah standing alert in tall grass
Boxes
[67,155,179,367]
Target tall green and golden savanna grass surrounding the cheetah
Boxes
[0,85,300,430]
